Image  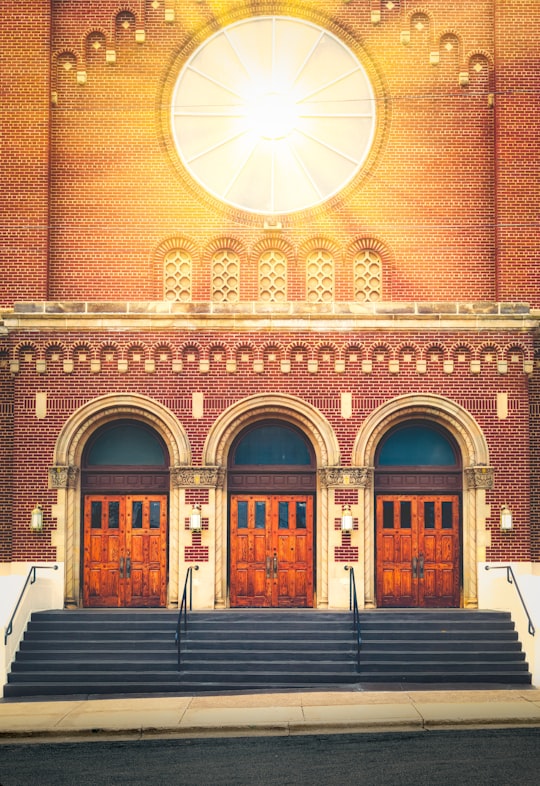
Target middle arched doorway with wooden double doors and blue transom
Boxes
[228,421,316,608]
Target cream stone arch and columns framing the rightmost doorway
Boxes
[352,394,493,608]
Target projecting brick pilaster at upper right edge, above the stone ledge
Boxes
[495,0,540,307]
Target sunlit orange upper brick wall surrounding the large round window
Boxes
[5,0,539,303]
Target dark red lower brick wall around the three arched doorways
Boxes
[5,324,531,560]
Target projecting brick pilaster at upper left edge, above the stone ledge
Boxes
[0,0,50,307]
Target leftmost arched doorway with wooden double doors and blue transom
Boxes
[81,419,169,607]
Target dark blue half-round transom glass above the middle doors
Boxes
[233,425,311,466]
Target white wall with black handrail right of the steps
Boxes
[478,562,540,686]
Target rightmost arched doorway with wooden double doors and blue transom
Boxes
[375,420,462,608]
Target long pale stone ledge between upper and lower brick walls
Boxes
[0,301,539,331]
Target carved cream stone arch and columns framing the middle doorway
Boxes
[203,393,340,608]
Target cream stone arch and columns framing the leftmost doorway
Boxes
[49,394,191,607]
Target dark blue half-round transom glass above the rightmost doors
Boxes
[377,425,457,467]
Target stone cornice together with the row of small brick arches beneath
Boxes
[4,310,538,377]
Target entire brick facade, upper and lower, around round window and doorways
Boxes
[0,0,540,608]
